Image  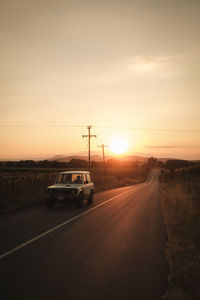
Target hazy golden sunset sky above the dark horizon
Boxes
[0,0,200,159]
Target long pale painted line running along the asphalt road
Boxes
[0,189,137,259]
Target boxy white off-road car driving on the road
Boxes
[46,171,95,208]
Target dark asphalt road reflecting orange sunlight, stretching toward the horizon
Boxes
[0,171,167,300]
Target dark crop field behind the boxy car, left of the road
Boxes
[0,168,148,211]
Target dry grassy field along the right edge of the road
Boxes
[160,166,200,300]
